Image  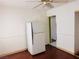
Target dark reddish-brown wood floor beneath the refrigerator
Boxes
[0,45,79,59]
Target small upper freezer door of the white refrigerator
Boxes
[32,22,45,33]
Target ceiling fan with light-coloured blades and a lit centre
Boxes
[26,0,68,8]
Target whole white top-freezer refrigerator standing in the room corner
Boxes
[26,22,45,55]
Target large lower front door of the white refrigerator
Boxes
[32,33,45,55]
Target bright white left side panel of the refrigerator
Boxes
[26,22,33,52]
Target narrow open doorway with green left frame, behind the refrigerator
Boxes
[49,16,57,47]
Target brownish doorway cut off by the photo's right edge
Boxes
[75,11,79,57]
